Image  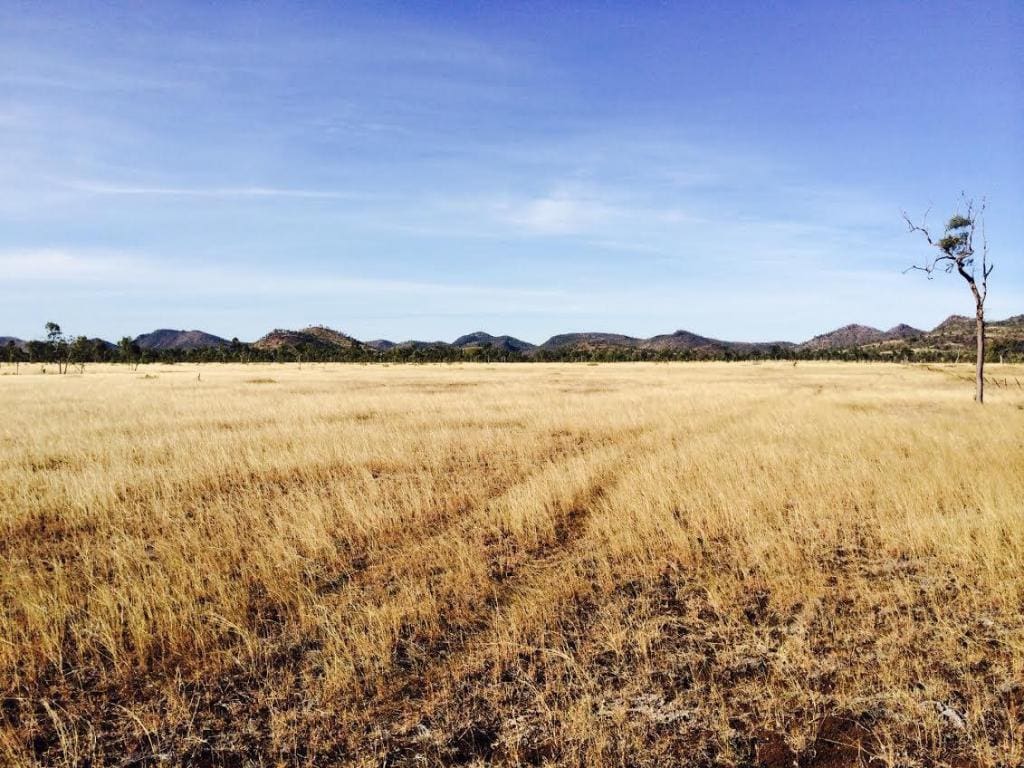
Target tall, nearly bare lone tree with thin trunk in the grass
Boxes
[903,194,992,403]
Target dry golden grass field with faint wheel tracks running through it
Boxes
[0,362,1024,766]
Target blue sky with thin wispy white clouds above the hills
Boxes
[0,0,1024,342]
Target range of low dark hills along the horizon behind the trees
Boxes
[0,314,1024,356]
